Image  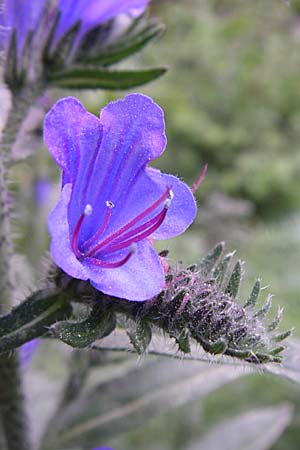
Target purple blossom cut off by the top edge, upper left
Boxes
[0,0,150,49]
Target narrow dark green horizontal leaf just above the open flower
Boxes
[48,67,167,90]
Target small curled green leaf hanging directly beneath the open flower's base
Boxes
[51,306,116,348]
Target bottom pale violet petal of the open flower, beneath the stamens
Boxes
[83,240,164,301]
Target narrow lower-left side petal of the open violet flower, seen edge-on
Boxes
[48,184,89,280]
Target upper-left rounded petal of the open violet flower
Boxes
[44,97,86,184]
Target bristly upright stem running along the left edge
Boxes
[0,88,38,450]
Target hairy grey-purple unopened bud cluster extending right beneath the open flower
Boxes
[52,244,290,363]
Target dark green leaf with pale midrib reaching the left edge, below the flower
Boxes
[0,289,72,353]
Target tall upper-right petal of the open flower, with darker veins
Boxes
[82,94,166,237]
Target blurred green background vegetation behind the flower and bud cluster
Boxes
[13,0,300,450]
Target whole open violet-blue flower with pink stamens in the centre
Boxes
[44,94,196,300]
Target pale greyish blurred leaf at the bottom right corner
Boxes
[188,404,293,450]
